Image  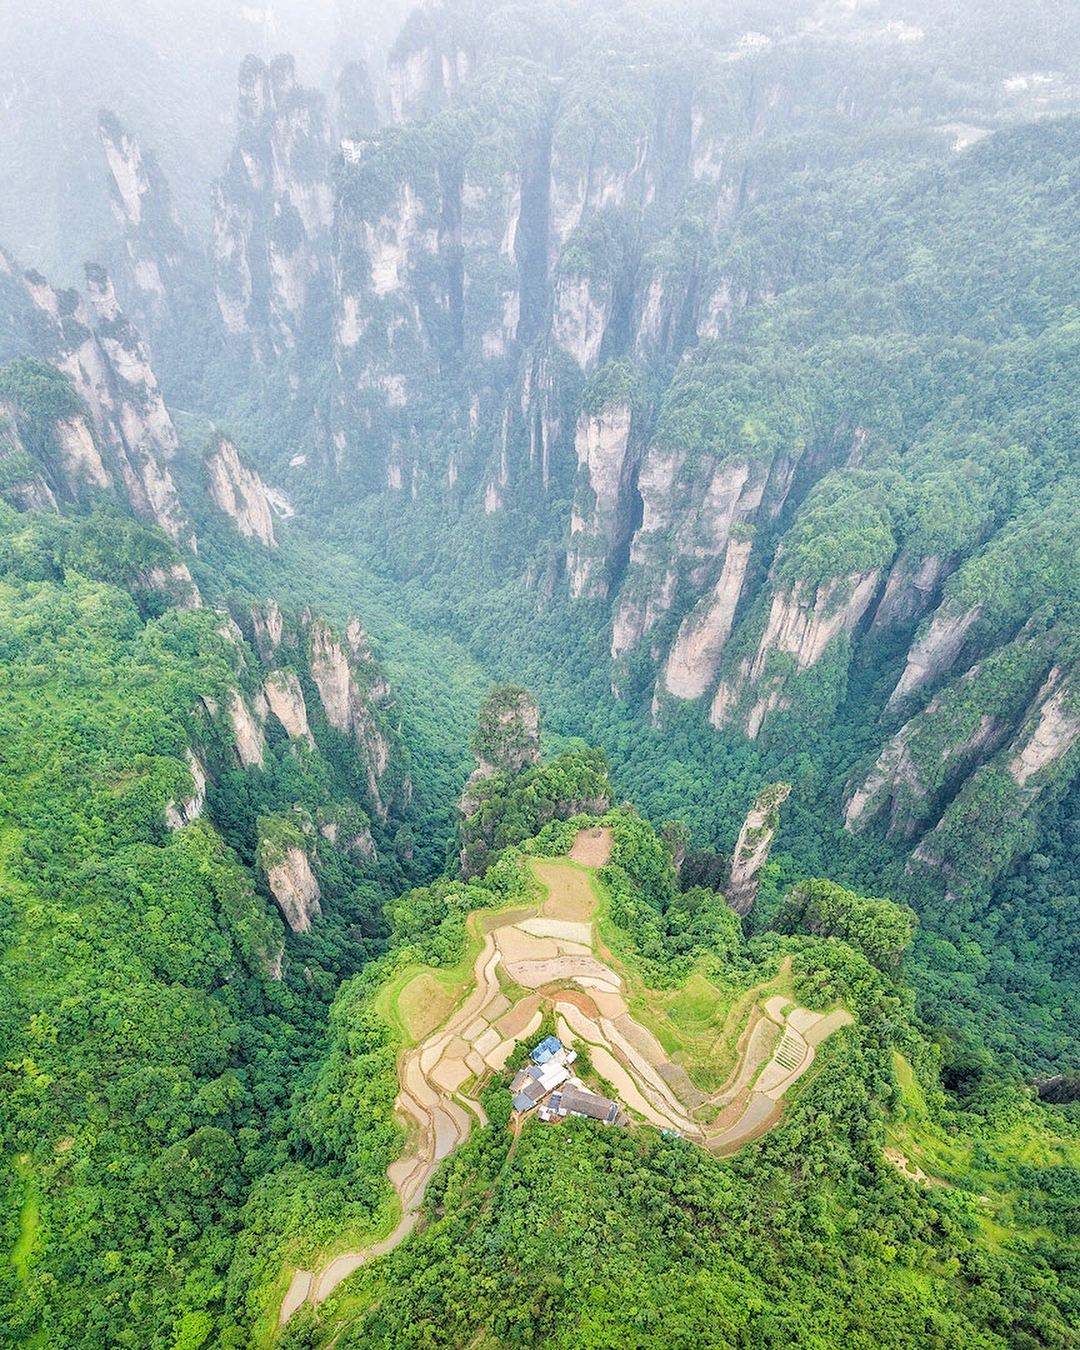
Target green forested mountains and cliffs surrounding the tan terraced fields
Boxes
[0,0,1080,1350]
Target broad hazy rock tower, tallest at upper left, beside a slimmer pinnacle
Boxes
[211,57,333,356]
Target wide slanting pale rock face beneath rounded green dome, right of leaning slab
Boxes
[709,570,880,740]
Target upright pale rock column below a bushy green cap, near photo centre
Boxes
[566,404,635,599]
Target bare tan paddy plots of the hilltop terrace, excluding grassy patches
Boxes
[278,829,852,1327]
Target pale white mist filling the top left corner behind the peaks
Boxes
[0,0,412,281]
